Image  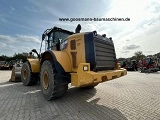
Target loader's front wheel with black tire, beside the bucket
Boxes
[21,62,39,86]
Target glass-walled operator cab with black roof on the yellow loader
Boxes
[42,27,74,51]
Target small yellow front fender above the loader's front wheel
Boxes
[28,58,40,73]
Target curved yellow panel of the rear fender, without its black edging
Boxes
[52,50,72,72]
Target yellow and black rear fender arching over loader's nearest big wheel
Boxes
[41,51,71,86]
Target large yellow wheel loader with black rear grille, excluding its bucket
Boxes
[21,25,127,100]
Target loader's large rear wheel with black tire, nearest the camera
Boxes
[40,60,68,100]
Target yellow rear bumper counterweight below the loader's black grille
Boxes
[71,63,127,87]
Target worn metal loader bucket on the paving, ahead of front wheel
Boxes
[9,65,22,82]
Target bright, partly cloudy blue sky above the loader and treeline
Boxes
[0,0,160,58]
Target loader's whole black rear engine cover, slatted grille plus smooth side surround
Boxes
[84,32,116,72]
